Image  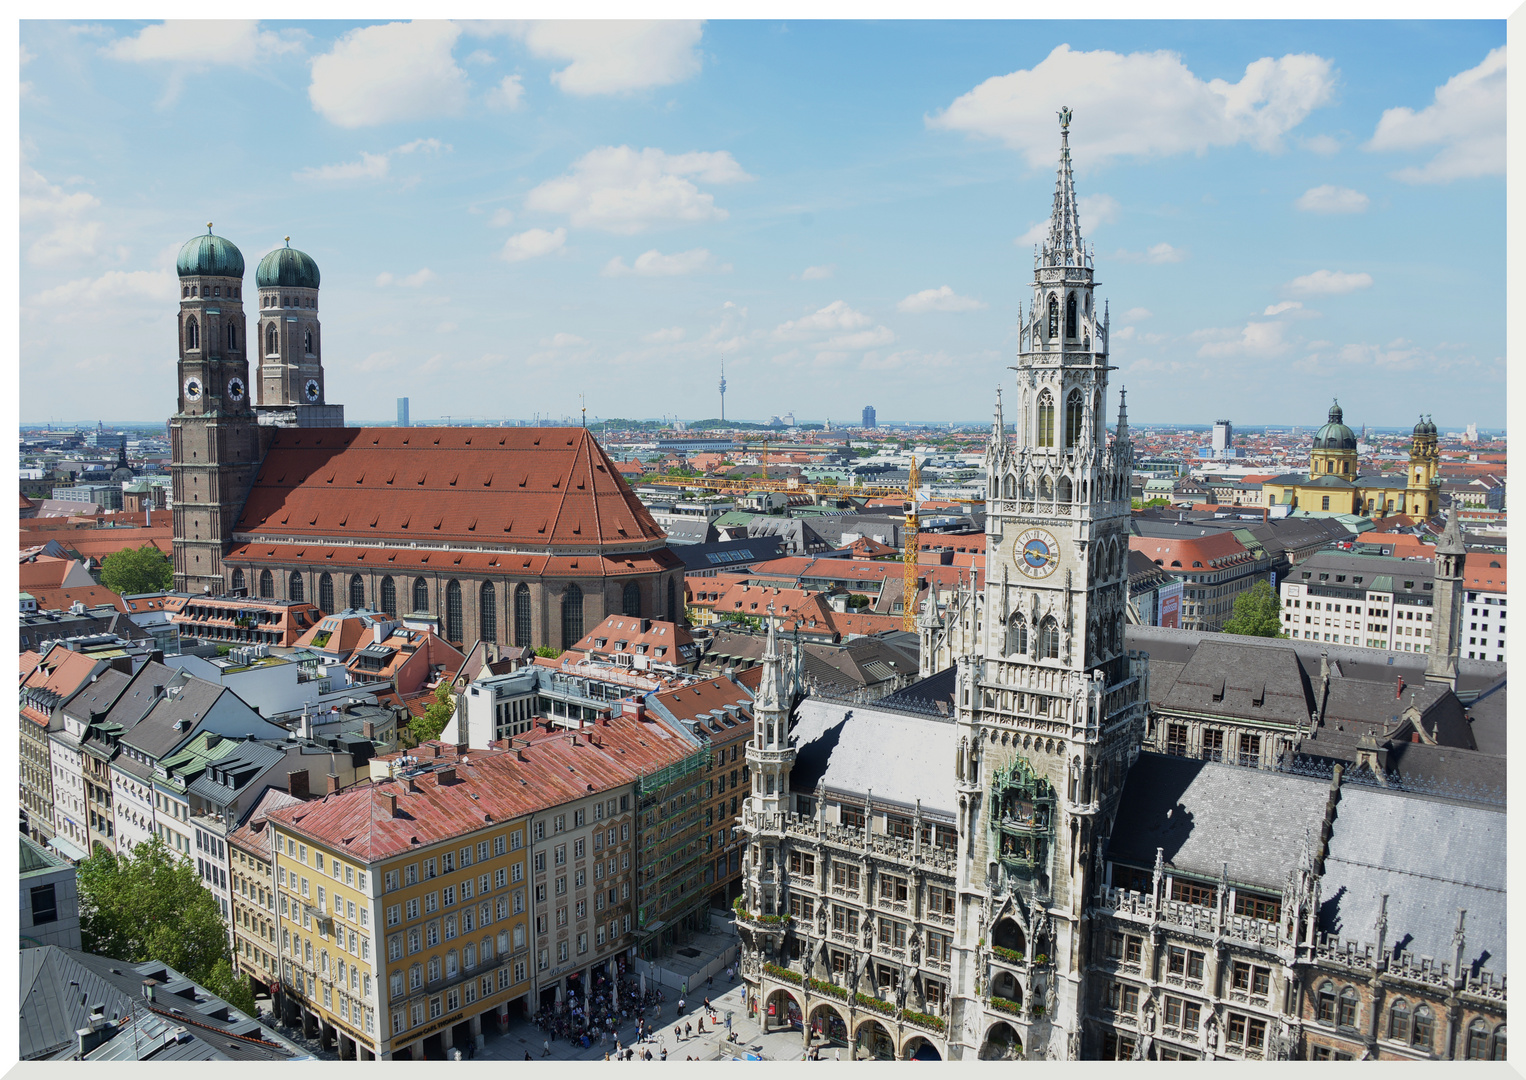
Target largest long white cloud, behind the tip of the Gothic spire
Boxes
[926,44,1335,168]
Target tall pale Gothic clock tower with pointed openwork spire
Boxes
[949,108,1148,1060]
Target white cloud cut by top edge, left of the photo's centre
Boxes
[504,20,703,96]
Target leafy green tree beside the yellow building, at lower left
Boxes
[78,836,231,994]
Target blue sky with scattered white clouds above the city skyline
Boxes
[20,21,1505,429]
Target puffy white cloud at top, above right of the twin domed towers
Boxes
[307,21,467,128]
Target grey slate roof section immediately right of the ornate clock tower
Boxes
[1108,752,1329,891]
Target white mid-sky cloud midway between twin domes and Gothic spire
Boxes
[525,146,751,235]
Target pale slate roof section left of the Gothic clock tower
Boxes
[789,697,958,816]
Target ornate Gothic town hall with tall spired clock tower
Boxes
[737,110,1505,1060]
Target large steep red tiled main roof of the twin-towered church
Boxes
[235,427,662,546]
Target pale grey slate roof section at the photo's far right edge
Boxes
[1320,786,1506,975]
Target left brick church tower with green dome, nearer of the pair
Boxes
[169,223,264,593]
